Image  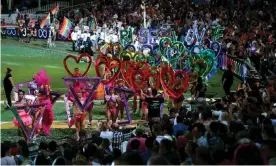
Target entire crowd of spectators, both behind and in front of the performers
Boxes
[1,0,276,165]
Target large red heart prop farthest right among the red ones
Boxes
[160,67,189,99]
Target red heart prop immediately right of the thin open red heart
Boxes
[95,56,121,84]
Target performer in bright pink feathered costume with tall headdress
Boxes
[34,70,54,136]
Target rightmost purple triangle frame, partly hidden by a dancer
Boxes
[104,86,134,125]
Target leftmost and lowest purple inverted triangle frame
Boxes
[11,104,47,143]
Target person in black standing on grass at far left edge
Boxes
[3,68,14,109]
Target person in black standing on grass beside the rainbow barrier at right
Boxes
[221,65,234,95]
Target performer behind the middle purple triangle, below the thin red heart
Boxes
[68,85,86,141]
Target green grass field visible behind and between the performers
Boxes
[1,38,239,143]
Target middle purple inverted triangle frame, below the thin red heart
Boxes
[63,77,102,112]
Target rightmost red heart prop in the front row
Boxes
[160,67,189,99]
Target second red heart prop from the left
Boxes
[95,56,121,84]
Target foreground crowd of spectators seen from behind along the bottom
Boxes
[1,86,276,165]
